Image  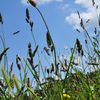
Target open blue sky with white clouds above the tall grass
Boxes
[0,0,100,75]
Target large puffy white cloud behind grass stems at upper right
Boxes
[65,0,100,28]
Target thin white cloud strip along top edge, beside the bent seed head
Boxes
[22,0,63,5]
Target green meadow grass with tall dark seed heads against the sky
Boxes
[0,0,100,100]
